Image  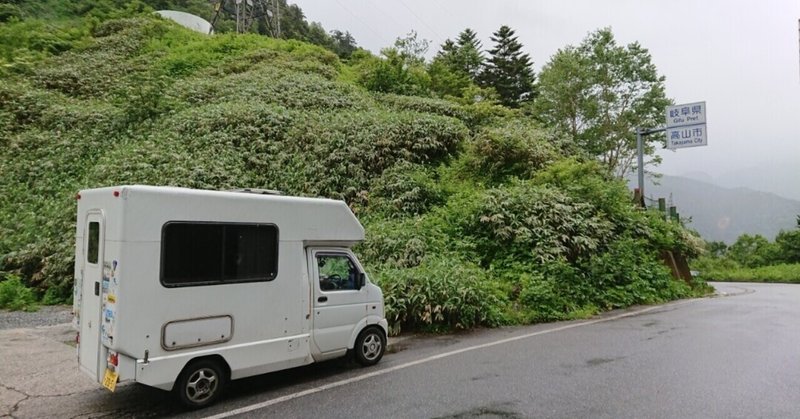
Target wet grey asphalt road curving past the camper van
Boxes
[0,284,800,419]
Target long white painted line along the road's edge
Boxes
[204,300,697,419]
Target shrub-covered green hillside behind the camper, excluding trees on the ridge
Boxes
[0,15,708,331]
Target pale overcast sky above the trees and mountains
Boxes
[300,0,800,189]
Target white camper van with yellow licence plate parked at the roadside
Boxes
[74,186,387,408]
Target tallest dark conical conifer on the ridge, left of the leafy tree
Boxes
[480,25,536,108]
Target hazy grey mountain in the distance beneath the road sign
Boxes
[632,175,800,244]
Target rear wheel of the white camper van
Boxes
[172,359,228,409]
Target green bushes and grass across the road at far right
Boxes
[692,216,800,283]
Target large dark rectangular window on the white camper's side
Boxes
[161,222,278,287]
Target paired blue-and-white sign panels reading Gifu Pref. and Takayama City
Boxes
[666,102,708,150]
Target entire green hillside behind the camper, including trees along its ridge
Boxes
[0,0,706,333]
